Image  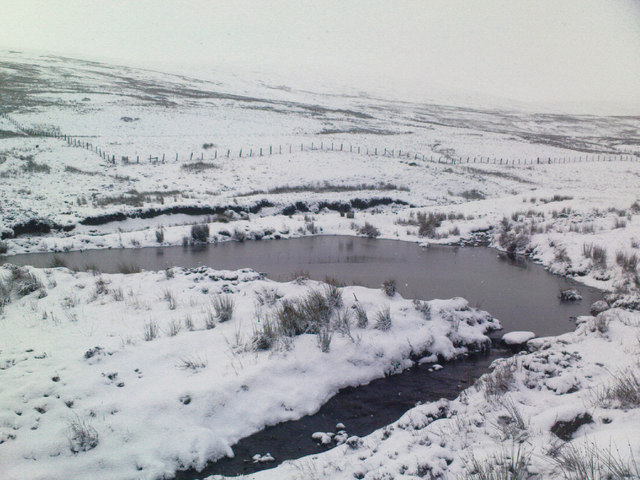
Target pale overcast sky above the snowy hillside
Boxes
[0,0,640,114]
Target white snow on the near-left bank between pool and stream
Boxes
[0,266,500,479]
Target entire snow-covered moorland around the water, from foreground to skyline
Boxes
[0,52,640,480]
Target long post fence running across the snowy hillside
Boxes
[0,113,640,166]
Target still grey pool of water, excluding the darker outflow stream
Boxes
[0,236,602,336]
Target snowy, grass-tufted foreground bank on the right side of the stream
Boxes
[240,309,640,480]
